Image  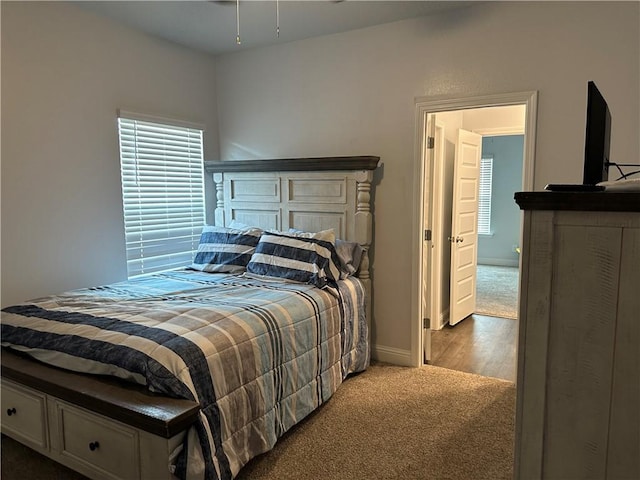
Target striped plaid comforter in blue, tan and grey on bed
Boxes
[1,270,369,479]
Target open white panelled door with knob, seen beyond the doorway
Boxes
[449,129,482,326]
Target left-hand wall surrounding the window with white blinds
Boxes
[1,2,218,305]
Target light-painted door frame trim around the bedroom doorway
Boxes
[410,91,538,367]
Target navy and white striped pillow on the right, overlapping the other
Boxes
[247,230,340,288]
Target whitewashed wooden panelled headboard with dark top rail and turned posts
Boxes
[204,156,380,320]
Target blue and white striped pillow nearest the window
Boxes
[191,225,262,273]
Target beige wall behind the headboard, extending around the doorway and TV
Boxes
[217,2,640,360]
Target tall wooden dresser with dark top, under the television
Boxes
[514,191,640,480]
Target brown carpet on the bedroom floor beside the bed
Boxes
[2,364,516,480]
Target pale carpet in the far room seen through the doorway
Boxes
[474,265,519,319]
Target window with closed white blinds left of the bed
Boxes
[118,112,204,278]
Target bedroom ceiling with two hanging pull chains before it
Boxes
[73,0,473,55]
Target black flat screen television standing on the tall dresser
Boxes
[582,81,611,185]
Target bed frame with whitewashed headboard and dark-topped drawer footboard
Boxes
[1,156,379,480]
